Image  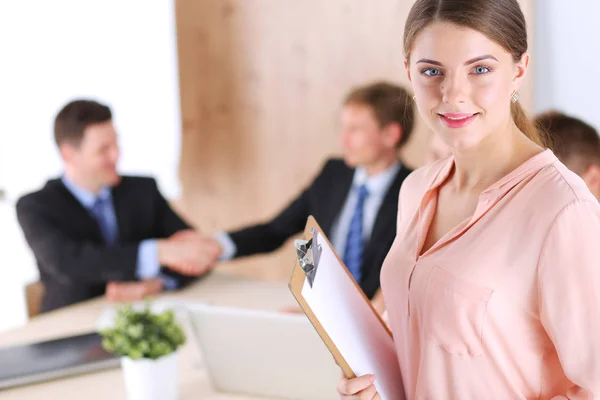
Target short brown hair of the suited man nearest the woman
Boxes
[344,82,415,147]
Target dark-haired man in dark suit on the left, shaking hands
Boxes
[17,100,218,311]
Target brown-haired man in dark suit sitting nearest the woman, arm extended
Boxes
[183,82,414,304]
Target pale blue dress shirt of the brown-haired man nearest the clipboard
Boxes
[215,162,402,261]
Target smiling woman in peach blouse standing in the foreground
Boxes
[339,0,600,400]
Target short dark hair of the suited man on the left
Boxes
[54,99,112,147]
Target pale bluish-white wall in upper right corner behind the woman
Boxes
[533,0,600,129]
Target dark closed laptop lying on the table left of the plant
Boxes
[0,333,120,389]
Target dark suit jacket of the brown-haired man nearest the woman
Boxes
[229,159,411,298]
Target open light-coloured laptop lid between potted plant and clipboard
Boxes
[189,304,341,400]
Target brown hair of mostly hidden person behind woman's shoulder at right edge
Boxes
[534,111,600,174]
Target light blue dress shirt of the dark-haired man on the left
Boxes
[62,175,178,290]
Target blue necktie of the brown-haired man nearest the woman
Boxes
[344,185,369,283]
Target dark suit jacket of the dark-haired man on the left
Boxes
[17,177,197,312]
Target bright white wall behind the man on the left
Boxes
[0,0,181,329]
